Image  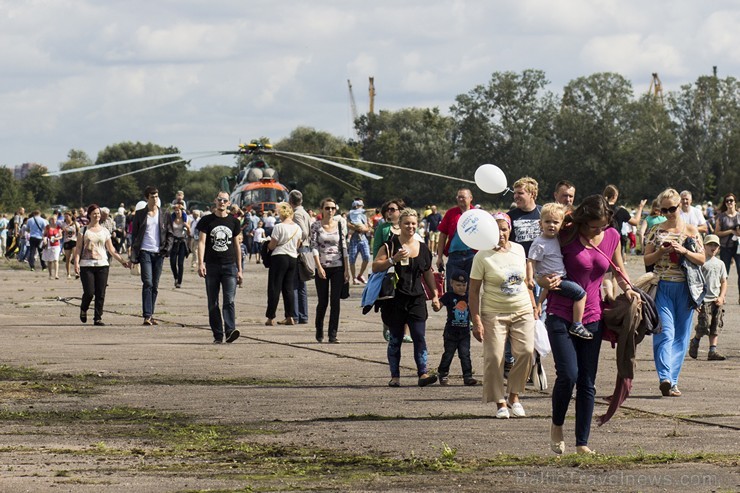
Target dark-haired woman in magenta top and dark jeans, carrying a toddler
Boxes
[538,195,637,454]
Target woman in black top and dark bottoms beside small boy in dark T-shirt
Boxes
[373,208,440,387]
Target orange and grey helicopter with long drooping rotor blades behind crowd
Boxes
[46,141,475,209]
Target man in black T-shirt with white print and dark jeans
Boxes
[198,192,243,344]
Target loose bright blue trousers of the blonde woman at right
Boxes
[653,281,694,385]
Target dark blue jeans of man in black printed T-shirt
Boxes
[206,264,238,341]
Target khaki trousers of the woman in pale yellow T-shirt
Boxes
[481,308,534,403]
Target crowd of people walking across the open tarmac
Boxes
[0,177,740,454]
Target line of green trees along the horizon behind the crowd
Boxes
[0,69,740,210]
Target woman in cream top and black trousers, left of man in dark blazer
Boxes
[75,204,130,325]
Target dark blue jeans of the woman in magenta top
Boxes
[545,314,602,446]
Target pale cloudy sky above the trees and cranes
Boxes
[0,0,740,170]
